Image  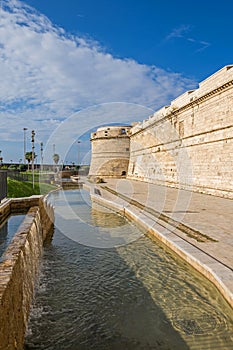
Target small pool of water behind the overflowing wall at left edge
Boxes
[0,214,25,257]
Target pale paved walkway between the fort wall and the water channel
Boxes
[85,179,233,307]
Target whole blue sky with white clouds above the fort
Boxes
[0,0,233,162]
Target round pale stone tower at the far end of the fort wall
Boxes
[89,125,131,178]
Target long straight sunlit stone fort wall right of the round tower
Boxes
[128,65,233,198]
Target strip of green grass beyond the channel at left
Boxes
[7,178,57,198]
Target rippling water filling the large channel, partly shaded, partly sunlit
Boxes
[25,190,233,350]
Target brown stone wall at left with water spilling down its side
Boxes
[0,198,54,350]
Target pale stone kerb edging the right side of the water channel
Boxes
[83,184,233,308]
